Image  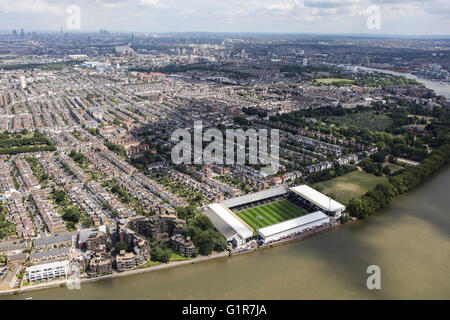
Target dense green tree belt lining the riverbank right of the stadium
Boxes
[347,144,450,218]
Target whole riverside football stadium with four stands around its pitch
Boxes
[204,185,345,247]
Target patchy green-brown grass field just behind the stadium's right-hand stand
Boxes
[314,170,387,205]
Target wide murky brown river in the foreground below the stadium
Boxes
[0,167,450,299]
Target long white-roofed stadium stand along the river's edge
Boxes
[258,211,330,243]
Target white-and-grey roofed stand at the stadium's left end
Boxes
[205,203,253,240]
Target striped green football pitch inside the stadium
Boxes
[236,200,306,230]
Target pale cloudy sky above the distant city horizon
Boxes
[0,0,450,35]
